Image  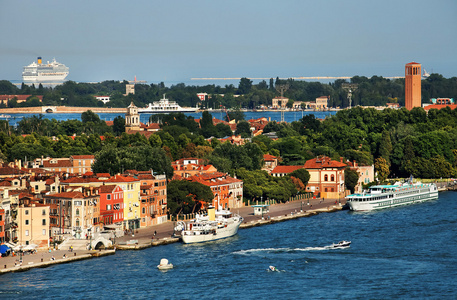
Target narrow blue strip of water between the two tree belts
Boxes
[2,111,336,126]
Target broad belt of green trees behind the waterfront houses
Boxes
[0,107,457,202]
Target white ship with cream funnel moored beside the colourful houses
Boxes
[175,207,243,244]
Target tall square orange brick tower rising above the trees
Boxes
[405,62,422,110]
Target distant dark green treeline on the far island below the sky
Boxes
[0,74,457,109]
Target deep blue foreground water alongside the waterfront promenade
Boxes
[0,192,457,300]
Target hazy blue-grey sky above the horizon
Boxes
[0,0,457,86]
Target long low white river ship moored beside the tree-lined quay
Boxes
[346,178,438,211]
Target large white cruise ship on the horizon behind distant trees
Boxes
[22,57,69,82]
